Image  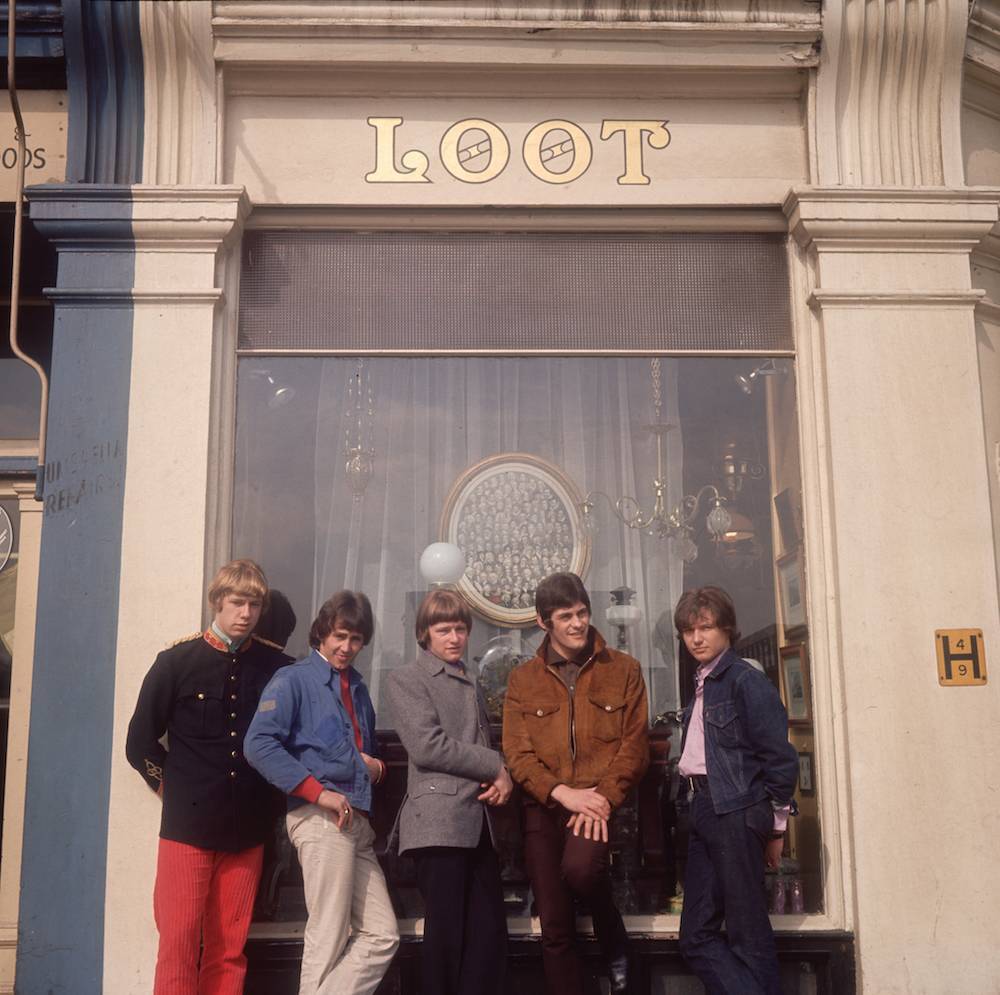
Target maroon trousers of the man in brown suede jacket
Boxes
[524,804,628,995]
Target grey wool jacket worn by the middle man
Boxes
[386,651,503,853]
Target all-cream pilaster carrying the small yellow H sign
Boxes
[785,188,1000,995]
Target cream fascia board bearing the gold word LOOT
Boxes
[222,92,809,209]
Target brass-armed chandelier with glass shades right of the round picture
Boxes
[580,356,764,563]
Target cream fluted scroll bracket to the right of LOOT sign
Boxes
[816,0,968,186]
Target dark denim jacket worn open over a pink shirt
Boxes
[681,650,799,815]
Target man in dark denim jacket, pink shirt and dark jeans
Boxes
[674,587,798,995]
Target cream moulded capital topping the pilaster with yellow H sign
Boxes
[782,187,1000,252]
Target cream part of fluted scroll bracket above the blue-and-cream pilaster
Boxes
[139,0,218,184]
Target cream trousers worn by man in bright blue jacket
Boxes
[285,805,399,995]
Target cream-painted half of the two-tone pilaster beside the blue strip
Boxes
[98,187,246,995]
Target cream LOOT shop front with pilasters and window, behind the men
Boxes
[0,0,1000,995]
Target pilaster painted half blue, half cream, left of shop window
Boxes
[18,186,248,995]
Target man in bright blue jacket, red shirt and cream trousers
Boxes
[244,591,399,995]
